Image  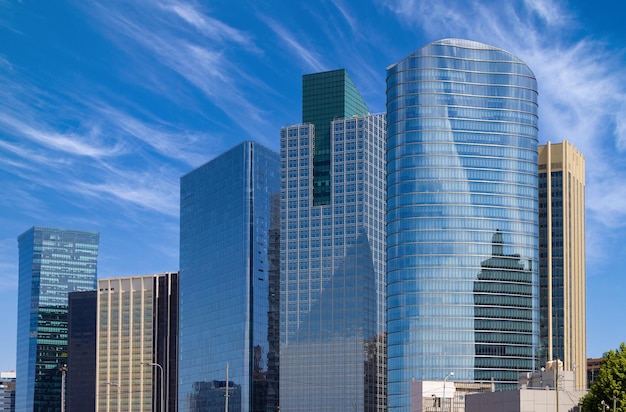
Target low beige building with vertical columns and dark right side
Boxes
[95,272,178,412]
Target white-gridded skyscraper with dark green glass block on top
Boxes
[280,70,386,412]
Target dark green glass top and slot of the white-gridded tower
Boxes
[302,69,369,206]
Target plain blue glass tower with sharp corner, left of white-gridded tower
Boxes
[179,142,279,412]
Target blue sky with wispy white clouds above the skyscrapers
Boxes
[0,0,626,370]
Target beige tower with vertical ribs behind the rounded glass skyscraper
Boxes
[539,141,587,389]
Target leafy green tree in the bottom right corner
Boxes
[582,342,626,412]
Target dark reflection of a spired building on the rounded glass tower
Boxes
[474,230,535,389]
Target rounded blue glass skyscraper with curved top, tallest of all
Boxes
[387,39,539,411]
